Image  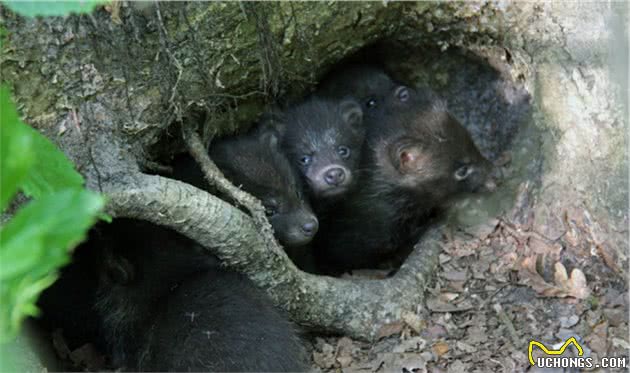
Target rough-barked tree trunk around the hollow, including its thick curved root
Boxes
[0,2,628,338]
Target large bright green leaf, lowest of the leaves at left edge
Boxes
[0,189,105,341]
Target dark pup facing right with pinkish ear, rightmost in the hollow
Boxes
[314,86,493,273]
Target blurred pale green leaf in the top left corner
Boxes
[2,0,104,17]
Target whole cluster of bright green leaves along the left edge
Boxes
[0,87,105,342]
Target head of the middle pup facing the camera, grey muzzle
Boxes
[266,97,365,201]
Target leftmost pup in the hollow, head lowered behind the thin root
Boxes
[173,130,319,247]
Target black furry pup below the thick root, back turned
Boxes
[95,220,307,372]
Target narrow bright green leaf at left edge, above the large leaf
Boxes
[0,85,35,211]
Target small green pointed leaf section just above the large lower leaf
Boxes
[21,125,83,197]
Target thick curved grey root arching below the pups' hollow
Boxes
[106,173,441,339]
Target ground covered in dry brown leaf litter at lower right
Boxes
[312,212,630,373]
